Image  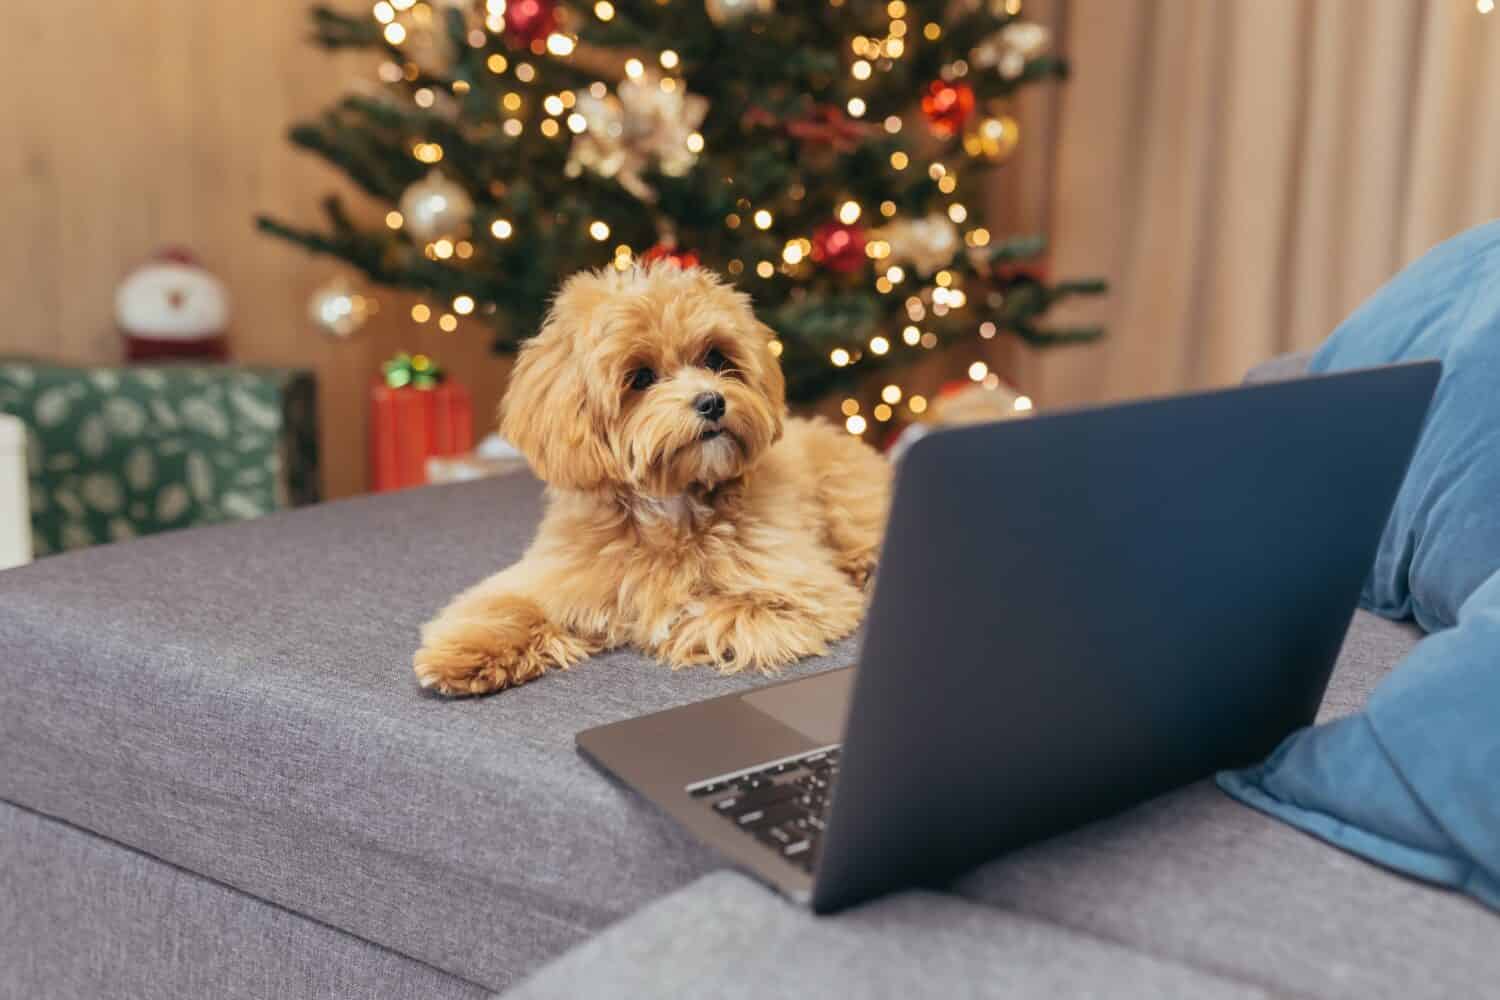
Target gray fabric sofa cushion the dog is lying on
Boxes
[0,475,851,988]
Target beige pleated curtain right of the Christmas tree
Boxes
[1023,0,1500,405]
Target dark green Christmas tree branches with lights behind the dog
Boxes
[257,0,1104,402]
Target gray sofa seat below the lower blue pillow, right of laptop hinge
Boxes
[957,783,1500,1000]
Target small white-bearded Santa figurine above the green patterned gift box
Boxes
[114,249,230,361]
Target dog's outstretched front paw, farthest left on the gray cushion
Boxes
[413,595,590,694]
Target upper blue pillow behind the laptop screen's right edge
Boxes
[1310,222,1500,631]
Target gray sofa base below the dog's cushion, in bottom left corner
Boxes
[0,802,488,1000]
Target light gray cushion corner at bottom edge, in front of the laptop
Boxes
[506,873,1266,1000]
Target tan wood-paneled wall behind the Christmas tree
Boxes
[0,0,1061,498]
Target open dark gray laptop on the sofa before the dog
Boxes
[578,361,1440,913]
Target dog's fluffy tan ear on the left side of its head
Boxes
[500,282,611,490]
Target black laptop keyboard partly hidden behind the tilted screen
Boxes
[687,747,839,873]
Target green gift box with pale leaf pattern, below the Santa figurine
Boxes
[0,360,318,555]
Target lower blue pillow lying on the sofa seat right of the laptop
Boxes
[1218,573,1500,910]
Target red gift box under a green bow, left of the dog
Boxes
[371,379,474,492]
